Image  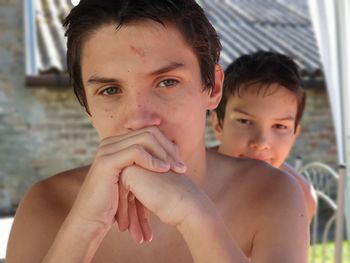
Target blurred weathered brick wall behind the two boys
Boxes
[0,0,336,215]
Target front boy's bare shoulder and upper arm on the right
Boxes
[243,165,309,262]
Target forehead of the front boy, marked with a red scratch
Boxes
[81,20,199,83]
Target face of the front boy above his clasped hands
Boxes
[81,20,222,158]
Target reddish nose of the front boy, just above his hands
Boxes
[125,100,161,131]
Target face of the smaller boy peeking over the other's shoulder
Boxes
[213,83,299,168]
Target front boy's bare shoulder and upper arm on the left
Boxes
[6,167,88,263]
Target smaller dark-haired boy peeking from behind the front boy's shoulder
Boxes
[212,51,316,221]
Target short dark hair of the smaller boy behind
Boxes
[215,51,306,129]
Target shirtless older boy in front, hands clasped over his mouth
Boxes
[6,0,309,263]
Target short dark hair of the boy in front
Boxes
[63,0,221,113]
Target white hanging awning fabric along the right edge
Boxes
[309,0,350,260]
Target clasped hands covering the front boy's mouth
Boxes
[71,127,201,243]
